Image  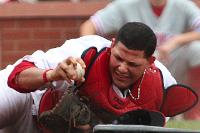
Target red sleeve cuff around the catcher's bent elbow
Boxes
[7,61,35,93]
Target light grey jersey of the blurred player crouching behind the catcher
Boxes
[91,0,200,44]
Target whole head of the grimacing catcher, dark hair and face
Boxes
[110,22,156,89]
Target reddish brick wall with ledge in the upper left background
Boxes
[0,1,108,69]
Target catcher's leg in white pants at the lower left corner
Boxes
[0,81,39,133]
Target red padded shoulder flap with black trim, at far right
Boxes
[161,84,198,117]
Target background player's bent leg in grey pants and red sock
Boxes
[167,41,200,120]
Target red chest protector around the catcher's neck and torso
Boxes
[79,48,163,116]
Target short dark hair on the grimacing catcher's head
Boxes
[116,22,157,57]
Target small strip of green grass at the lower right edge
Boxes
[166,120,200,131]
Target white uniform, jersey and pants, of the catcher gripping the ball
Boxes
[0,35,176,133]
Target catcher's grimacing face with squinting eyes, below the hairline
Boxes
[110,42,150,89]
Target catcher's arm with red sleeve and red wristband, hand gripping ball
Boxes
[8,57,85,92]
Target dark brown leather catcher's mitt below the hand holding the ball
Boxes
[38,89,90,133]
